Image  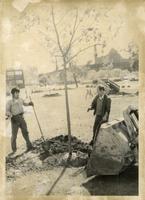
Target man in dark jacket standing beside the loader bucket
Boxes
[87,85,111,145]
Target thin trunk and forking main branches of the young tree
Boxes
[51,6,109,154]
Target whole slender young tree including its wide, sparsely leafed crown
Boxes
[12,4,125,156]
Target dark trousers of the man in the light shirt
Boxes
[11,114,32,151]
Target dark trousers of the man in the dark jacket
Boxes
[92,115,102,143]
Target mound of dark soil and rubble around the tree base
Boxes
[6,135,91,180]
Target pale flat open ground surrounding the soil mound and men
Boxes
[6,83,138,196]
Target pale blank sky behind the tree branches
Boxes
[2,0,139,73]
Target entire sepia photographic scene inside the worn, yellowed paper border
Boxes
[2,0,139,197]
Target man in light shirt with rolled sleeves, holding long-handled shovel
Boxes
[6,88,34,154]
